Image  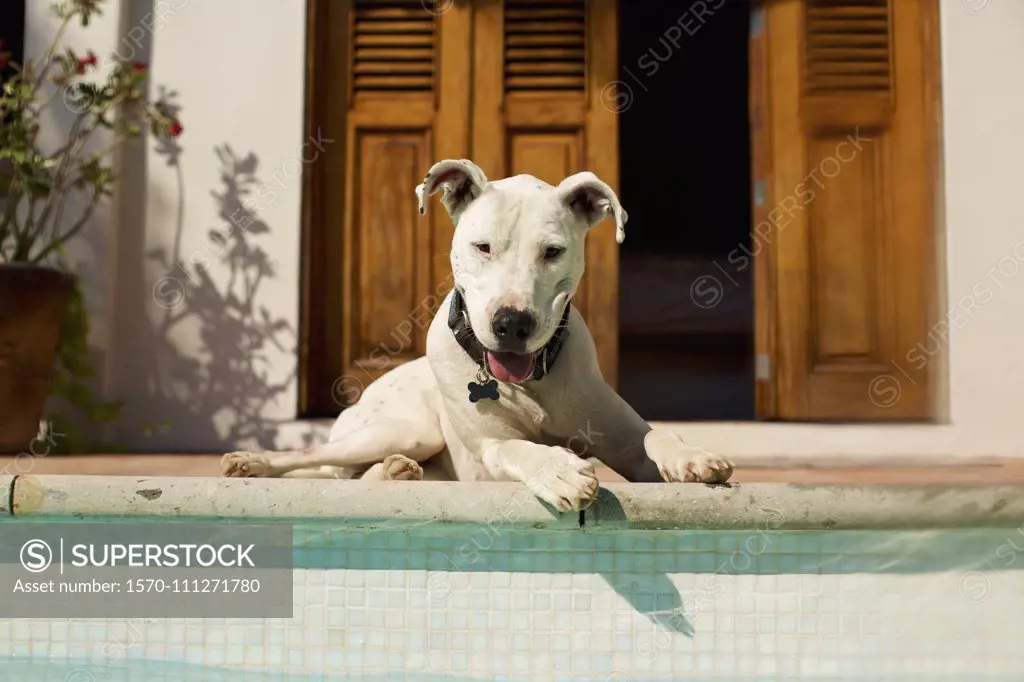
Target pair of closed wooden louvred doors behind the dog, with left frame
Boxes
[300,0,628,409]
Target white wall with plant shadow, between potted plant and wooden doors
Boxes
[28,0,315,452]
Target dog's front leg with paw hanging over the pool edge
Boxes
[482,440,598,512]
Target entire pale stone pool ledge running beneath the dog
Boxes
[8,475,1024,530]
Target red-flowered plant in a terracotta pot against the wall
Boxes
[0,0,182,454]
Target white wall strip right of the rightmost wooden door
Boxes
[942,0,1024,455]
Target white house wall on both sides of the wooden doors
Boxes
[29,0,1024,461]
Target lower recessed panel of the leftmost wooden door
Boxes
[341,120,438,382]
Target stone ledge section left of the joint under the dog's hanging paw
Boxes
[13,475,580,529]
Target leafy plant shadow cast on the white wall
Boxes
[145,144,303,450]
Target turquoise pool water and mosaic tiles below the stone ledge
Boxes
[0,519,1024,682]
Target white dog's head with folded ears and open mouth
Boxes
[416,160,627,382]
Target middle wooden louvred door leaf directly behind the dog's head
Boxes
[471,0,629,385]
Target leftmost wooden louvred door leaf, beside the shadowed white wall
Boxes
[337,0,471,399]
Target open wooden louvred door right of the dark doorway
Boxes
[752,0,938,420]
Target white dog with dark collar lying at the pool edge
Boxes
[221,160,732,511]
